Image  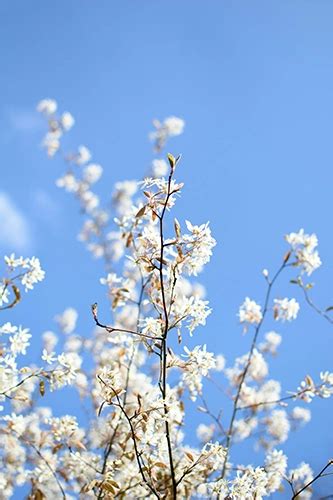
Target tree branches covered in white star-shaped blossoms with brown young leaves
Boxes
[0,99,333,500]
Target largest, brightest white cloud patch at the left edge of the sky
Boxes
[0,191,32,252]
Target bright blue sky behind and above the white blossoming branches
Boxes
[0,0,333,498]
